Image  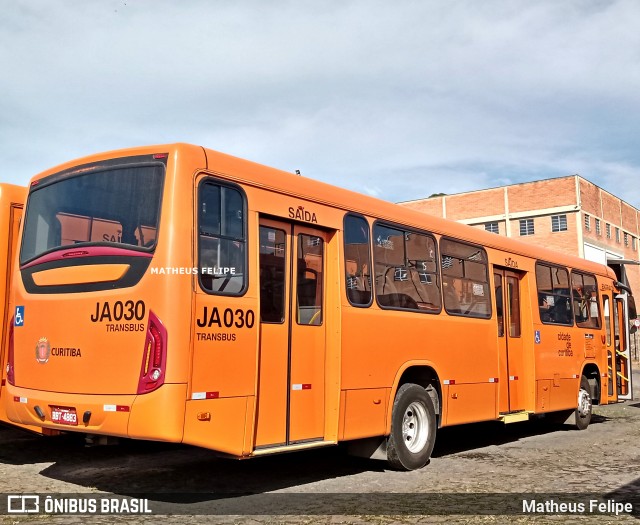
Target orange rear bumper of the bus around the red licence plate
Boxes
[3,384,187,442]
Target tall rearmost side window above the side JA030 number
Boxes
[198,180,247,295]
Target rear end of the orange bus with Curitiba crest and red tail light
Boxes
[5,146,195,441]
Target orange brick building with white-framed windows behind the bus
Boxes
[400,175,640,324]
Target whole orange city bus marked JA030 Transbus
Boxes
[3,144,632,469]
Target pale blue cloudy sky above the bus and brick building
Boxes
[0,0,640,208]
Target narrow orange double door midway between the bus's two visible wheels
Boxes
[493,267,525,414]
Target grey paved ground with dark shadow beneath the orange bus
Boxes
[0,368,640,525]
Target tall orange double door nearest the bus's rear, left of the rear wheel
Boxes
[255,219,327,448]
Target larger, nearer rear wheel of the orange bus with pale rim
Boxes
[387,383,436,470]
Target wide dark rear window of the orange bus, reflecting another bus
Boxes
[20,164,164,264]
